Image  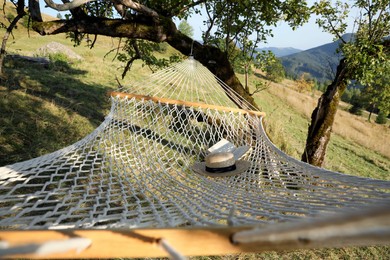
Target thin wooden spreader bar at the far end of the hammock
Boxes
[109,92,266,117]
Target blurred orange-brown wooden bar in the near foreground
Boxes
[0,225,261,259]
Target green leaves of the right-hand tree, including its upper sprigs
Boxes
[312,0,390,116]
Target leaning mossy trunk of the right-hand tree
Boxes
[302,59,347,167]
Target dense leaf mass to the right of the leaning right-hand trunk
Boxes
[341,0,390,116]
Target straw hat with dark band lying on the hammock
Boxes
[192,152,251,177]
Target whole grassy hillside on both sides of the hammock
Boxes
[0,8,390,259]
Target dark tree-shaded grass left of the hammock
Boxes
[0,57,114,166]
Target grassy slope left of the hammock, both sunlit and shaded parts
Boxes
[0,18,155,166]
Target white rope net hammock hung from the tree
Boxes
[0,57,390,257]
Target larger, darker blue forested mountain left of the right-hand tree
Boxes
[280,34,353,82]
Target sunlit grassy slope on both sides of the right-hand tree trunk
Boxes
[250,76,390,180]
